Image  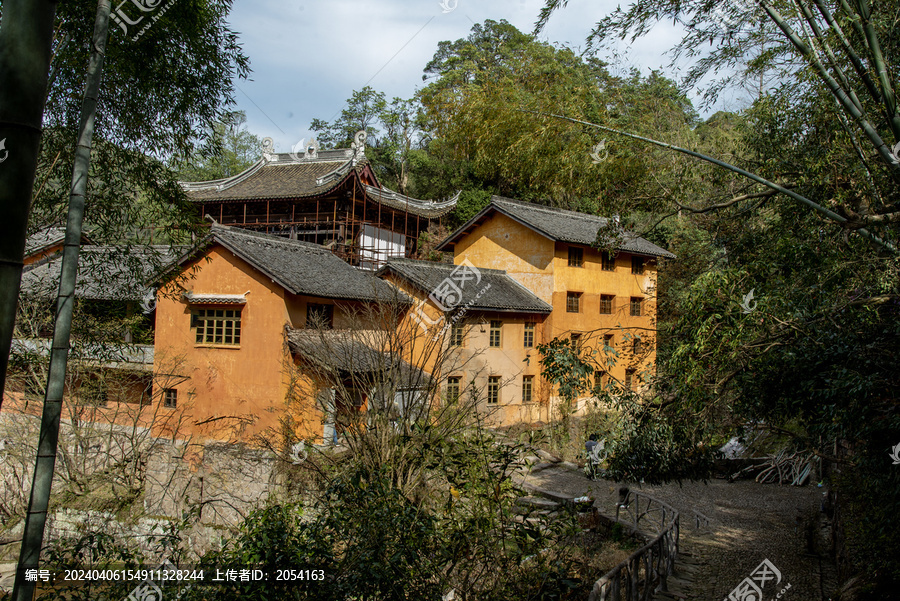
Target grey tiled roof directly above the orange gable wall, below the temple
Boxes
[179,224,407,302]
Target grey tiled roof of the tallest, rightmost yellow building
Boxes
[437,196,675,258]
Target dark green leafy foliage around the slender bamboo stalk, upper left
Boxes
[29,0,249,242]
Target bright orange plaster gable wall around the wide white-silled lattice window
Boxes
[155,247,297,440]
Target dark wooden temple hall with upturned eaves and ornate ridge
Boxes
[182,132,458,269]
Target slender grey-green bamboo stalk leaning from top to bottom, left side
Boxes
[13,0,110,601]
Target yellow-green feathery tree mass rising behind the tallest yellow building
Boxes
[419,20,695,214]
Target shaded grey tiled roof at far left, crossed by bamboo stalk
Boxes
[22,246,185,301]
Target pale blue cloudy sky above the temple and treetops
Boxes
[229,0,724,152]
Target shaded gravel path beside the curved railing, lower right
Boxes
[526,464,837,601]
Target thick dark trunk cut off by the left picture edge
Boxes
[0,0,56,406]
